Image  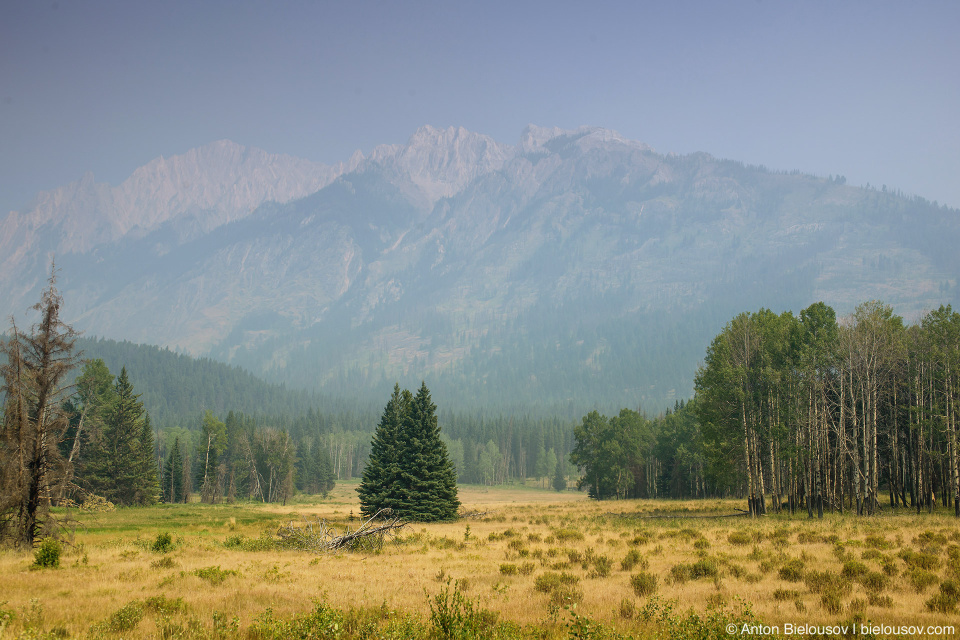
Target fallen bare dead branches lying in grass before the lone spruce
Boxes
[277,509,407,553]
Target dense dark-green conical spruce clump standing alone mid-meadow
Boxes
[357,384,460,522]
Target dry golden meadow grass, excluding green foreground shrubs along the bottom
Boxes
[0,483,960,637]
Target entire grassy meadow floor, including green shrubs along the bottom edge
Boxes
[0,483,960,638]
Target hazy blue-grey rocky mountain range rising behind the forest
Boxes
[0,126,960,412]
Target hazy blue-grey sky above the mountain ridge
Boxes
[0,0,960,213]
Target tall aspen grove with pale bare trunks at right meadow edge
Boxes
[696,302,960,515]
